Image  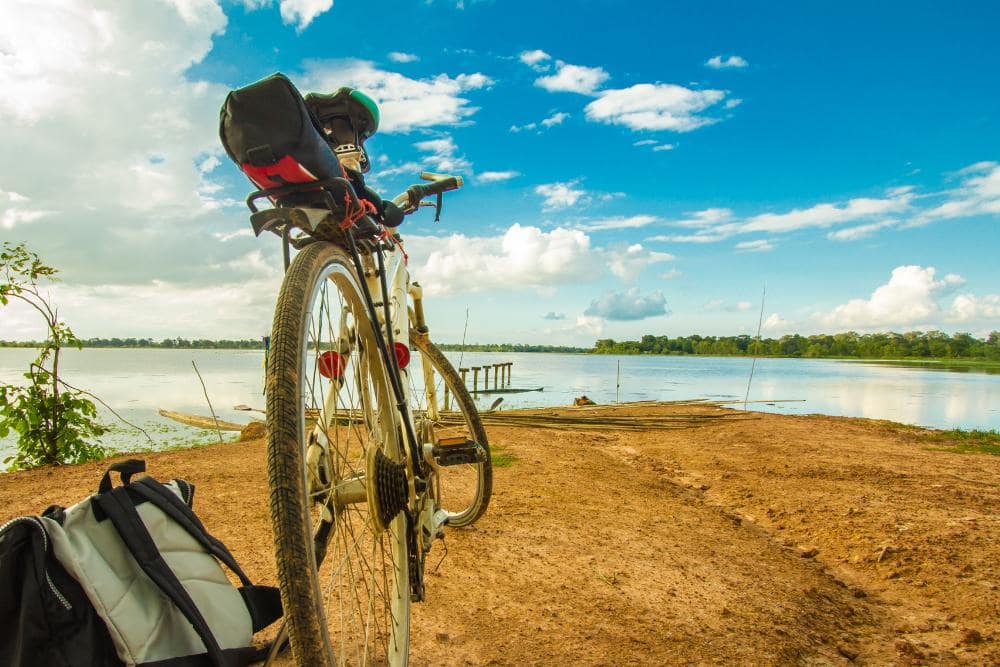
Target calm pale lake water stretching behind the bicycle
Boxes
[0,348,1000,460]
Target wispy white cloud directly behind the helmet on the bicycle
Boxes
[302,60,493,133]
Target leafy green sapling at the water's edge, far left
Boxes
[0,242,107,470]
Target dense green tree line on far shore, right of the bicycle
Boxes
[593,331,1000,361]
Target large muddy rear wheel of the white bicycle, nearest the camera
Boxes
[267,243,410,665]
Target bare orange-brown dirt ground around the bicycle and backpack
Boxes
[0,406,1000,665]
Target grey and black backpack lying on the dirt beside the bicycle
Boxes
[0,460,282,667]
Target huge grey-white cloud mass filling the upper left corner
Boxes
[0,0,245,284]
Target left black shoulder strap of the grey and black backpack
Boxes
[93,487,231,667]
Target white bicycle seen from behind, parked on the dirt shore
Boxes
[224,73,492,665]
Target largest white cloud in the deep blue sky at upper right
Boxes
[584,83,726,132]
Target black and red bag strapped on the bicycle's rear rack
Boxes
[219,73,344,206]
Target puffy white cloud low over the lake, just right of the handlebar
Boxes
[406,223,600,295]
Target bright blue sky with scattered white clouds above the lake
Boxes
[0,0,1000,345]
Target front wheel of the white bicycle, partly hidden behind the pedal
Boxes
[410,331,493,527]
